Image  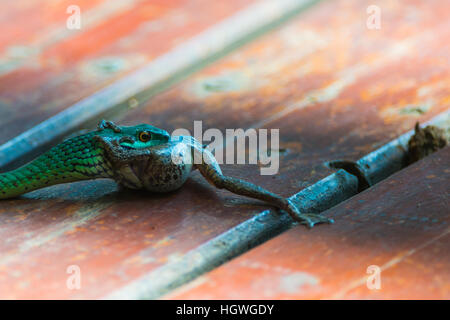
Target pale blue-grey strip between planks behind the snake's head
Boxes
[0,0,319,169]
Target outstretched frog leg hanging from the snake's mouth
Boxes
[194,144,333,228]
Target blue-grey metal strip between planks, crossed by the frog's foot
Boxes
[105,111,450,299]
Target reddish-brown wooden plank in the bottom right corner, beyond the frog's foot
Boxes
[166,147,450,299]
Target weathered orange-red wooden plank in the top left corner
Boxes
[0,0,254,143]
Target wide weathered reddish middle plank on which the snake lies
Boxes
[0,0,450,298]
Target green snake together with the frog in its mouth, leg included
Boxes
[0,120,333,227]
